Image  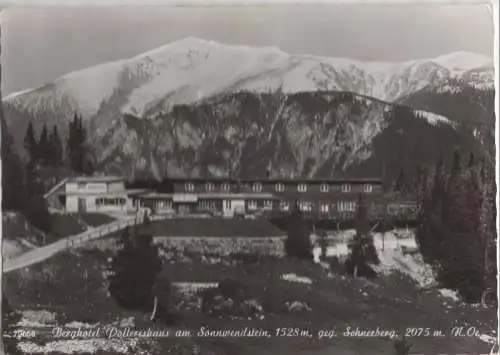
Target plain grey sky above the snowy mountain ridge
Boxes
[0,4,494,95]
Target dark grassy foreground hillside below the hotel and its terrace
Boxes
[4,229,495,355]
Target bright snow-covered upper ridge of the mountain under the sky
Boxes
[4,38,493,118]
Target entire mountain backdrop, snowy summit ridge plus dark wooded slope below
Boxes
[0,38,493,181]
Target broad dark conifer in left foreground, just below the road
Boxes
[109,220,162,312]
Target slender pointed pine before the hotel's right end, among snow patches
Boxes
[346,194,380,277]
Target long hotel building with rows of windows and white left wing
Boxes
[46,176,416,219]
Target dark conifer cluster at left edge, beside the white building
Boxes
[1,112,93,232]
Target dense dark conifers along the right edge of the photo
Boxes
[416,151,497,305]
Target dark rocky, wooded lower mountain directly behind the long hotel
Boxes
[95,92,473,180]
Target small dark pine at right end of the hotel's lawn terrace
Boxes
[285,202,314,260]
